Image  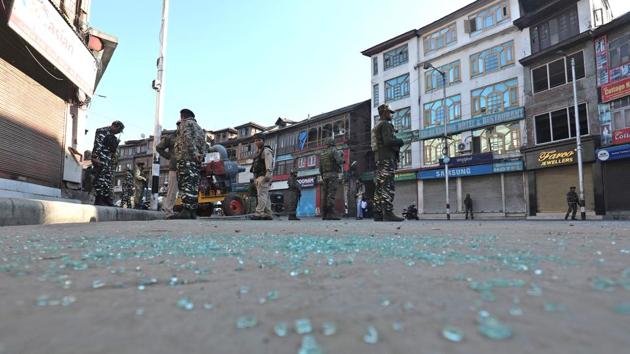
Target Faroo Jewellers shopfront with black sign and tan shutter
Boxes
[525,140,600,216]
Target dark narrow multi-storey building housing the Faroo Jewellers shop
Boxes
[514,0,612,216]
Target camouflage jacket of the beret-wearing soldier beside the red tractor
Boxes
[173,118,206,161]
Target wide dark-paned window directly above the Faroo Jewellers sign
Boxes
[534,103,588,144]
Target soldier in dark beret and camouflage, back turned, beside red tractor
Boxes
[169,109,206,219]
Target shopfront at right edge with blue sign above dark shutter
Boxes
[597,144,630,217]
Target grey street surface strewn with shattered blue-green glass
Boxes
[0,219,630,354]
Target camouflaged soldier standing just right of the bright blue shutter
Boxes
[319,139,344,220]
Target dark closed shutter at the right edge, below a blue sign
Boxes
[604,160,630,211]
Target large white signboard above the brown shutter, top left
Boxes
[9,0,97,96]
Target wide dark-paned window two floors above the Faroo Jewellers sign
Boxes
[532,52,585,93]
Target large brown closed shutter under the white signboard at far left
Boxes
[0,58,66,188]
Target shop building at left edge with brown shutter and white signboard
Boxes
[0,0,117,198]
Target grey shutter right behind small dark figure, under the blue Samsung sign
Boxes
[462,174,503,213]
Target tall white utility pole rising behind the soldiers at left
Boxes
[151,0,170,210]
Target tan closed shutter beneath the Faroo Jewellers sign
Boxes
[536,164,595,213]
